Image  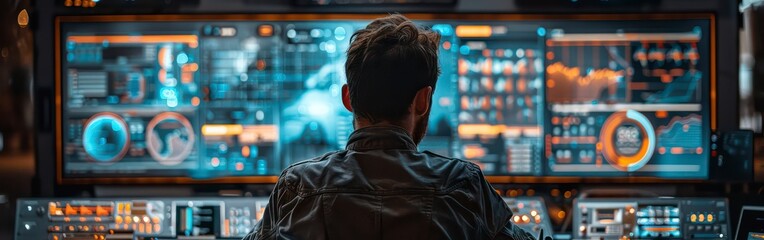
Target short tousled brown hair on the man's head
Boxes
[345,14,440,123]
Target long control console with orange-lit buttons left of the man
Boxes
[15,198,268,240]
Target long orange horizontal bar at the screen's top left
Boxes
[66,35,199,48]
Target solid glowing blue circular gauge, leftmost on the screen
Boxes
[82,113,130,163]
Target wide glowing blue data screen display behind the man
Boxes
[57,15,711,180]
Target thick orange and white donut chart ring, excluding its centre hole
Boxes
[600,110,656,172]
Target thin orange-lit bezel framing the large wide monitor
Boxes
[54,13,717,185]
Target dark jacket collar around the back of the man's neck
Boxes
[346,126,417,151]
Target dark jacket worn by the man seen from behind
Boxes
[244,126,533,240]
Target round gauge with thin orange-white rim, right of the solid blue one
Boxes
[146,112,194,166]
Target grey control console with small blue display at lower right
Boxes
[573,198,731,239]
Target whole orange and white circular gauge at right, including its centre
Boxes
[600,110,655,172]
